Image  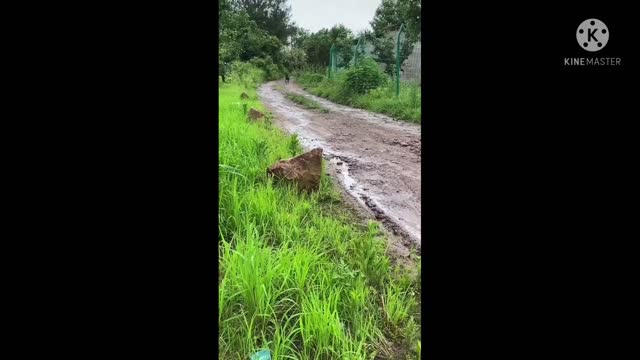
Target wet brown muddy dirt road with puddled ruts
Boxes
[258,81,422,255]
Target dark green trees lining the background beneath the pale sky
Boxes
[218,0,422,79]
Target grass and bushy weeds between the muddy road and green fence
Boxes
[296,73,422,123]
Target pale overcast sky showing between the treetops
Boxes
[289,0,382,33]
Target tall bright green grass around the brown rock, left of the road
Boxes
[218,68,420,360]
